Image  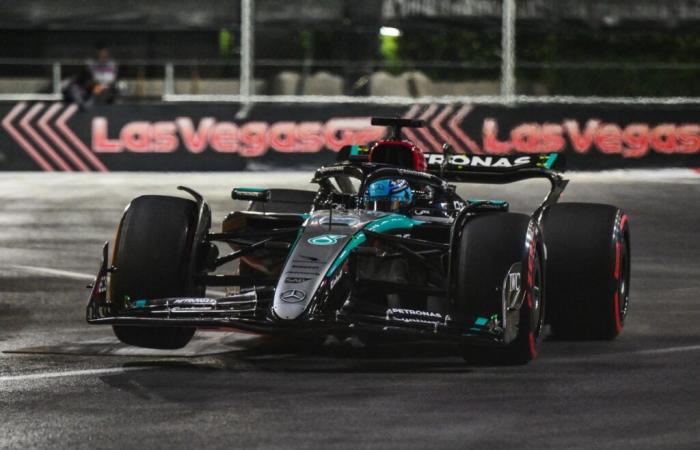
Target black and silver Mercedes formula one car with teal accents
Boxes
[87,118,630,364]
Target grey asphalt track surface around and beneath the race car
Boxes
[0,172,700,449]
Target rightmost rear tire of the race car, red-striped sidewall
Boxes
[543,203,630,340]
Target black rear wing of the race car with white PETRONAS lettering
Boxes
[424,153,565,183]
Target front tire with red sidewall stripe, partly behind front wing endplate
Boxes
[456,213,545,365]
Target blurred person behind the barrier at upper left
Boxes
[63,44,119,109]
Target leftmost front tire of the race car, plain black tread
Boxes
[109,195,205,350]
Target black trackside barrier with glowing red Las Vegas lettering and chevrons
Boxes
[0,98,700,171]
